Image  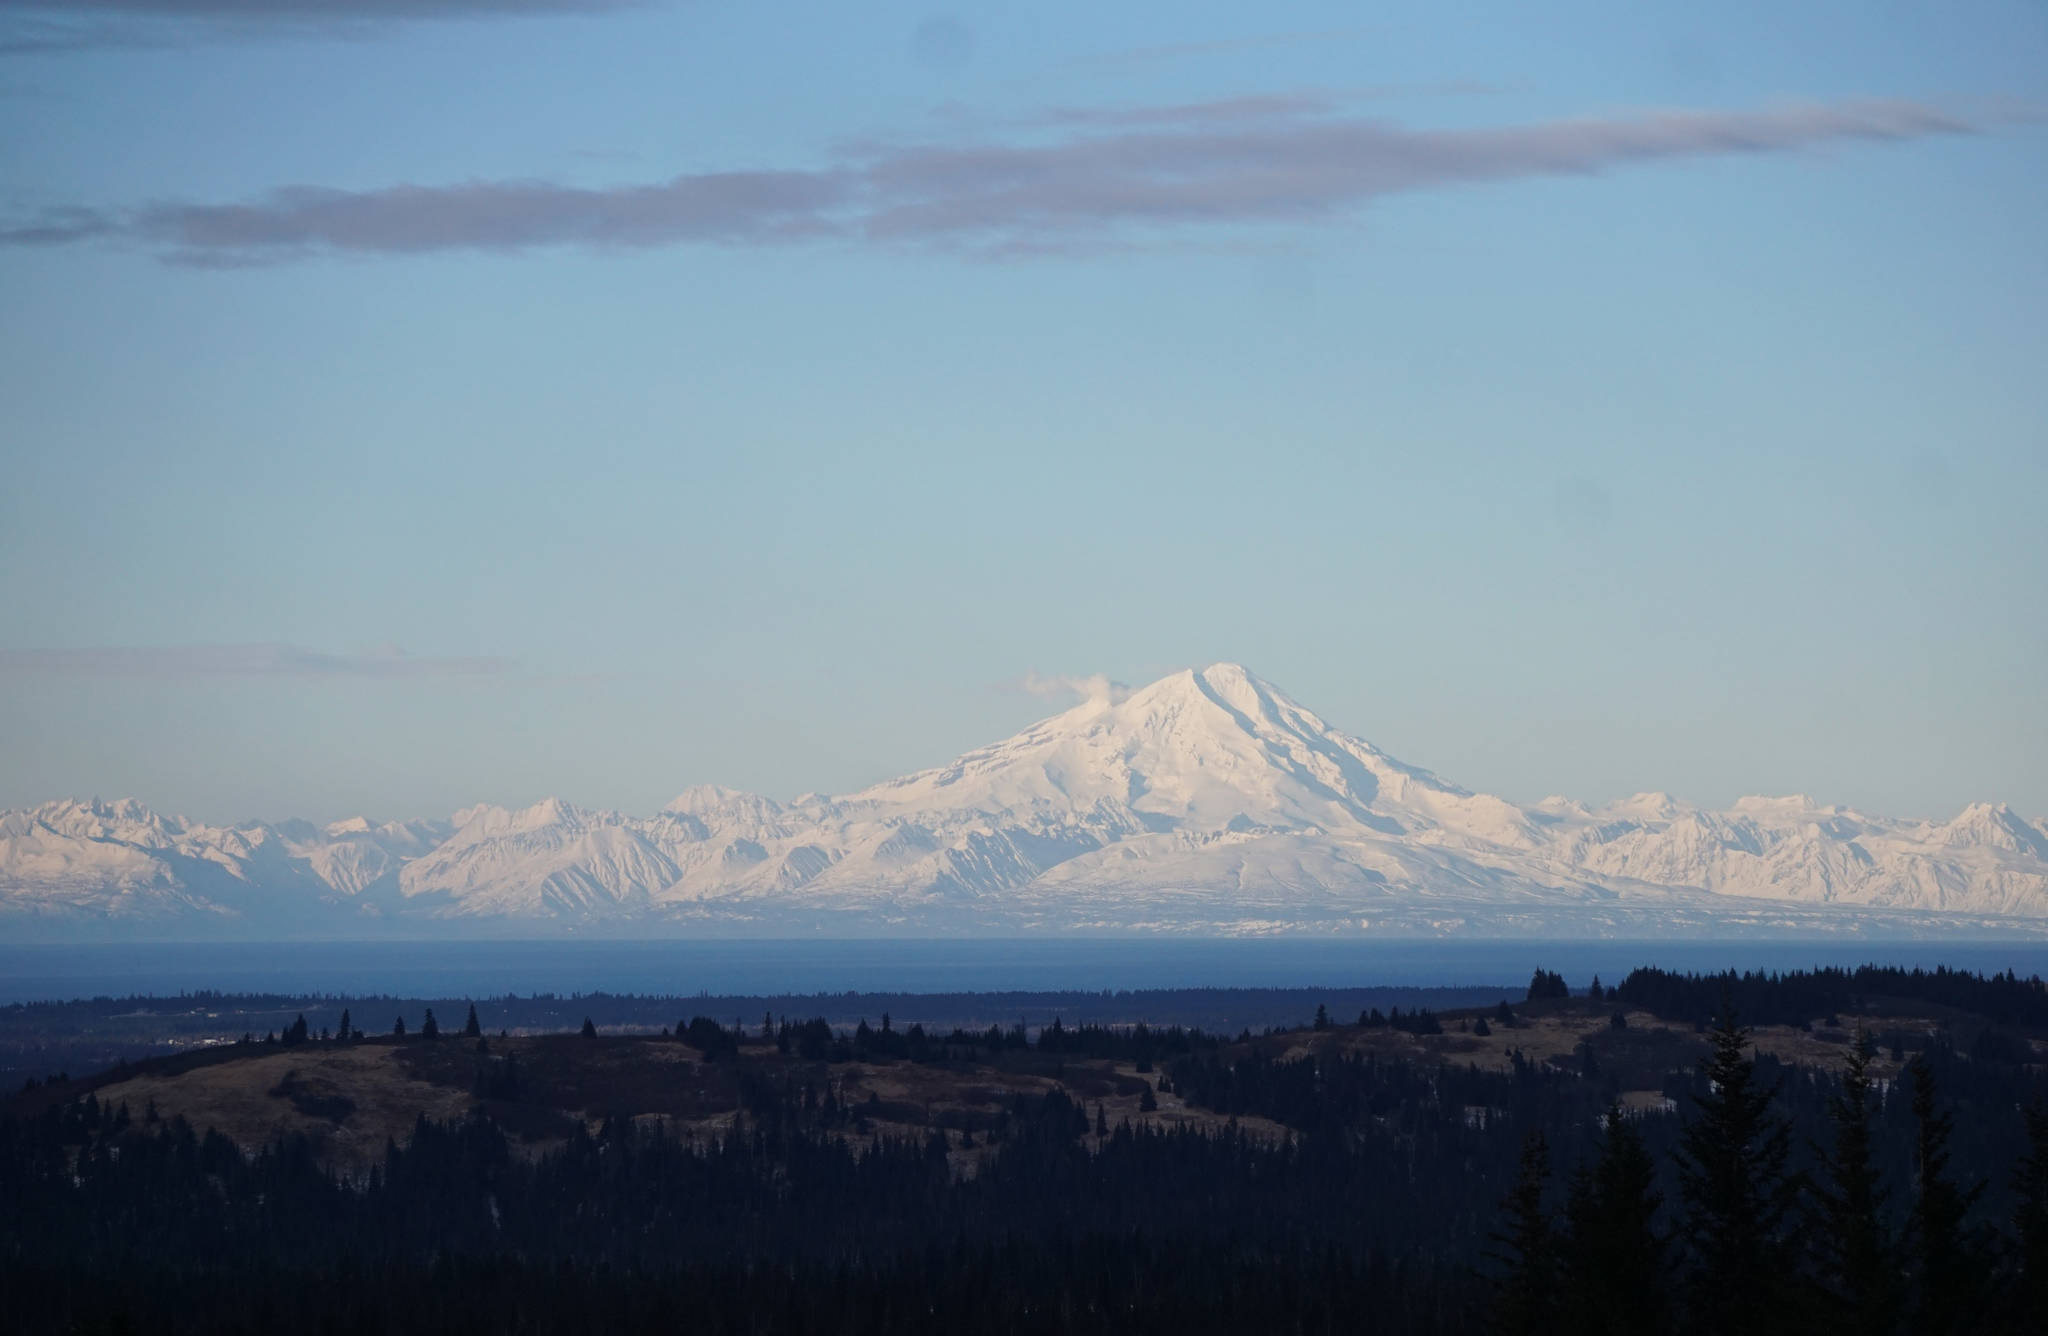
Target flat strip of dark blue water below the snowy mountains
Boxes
[0,938,2048,1004]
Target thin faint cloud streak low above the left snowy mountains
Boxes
[0,643,516,678]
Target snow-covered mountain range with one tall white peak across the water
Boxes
[0,664,2048,941]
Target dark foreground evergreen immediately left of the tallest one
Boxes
[1563,1104,1669,1336]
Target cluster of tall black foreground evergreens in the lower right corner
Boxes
[1489,1012,2048,1336]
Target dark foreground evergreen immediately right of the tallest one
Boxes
[1808,1031,1898,1336]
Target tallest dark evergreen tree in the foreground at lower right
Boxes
[1677,1004,1798,1332]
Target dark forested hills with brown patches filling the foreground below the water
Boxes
[0,973,2048,1332]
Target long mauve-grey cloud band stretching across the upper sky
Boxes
[0,98,1976,264]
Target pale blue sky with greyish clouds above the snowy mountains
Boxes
[0,0,2048,822]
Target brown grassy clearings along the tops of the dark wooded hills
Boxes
[59,1000,1966,1172]
